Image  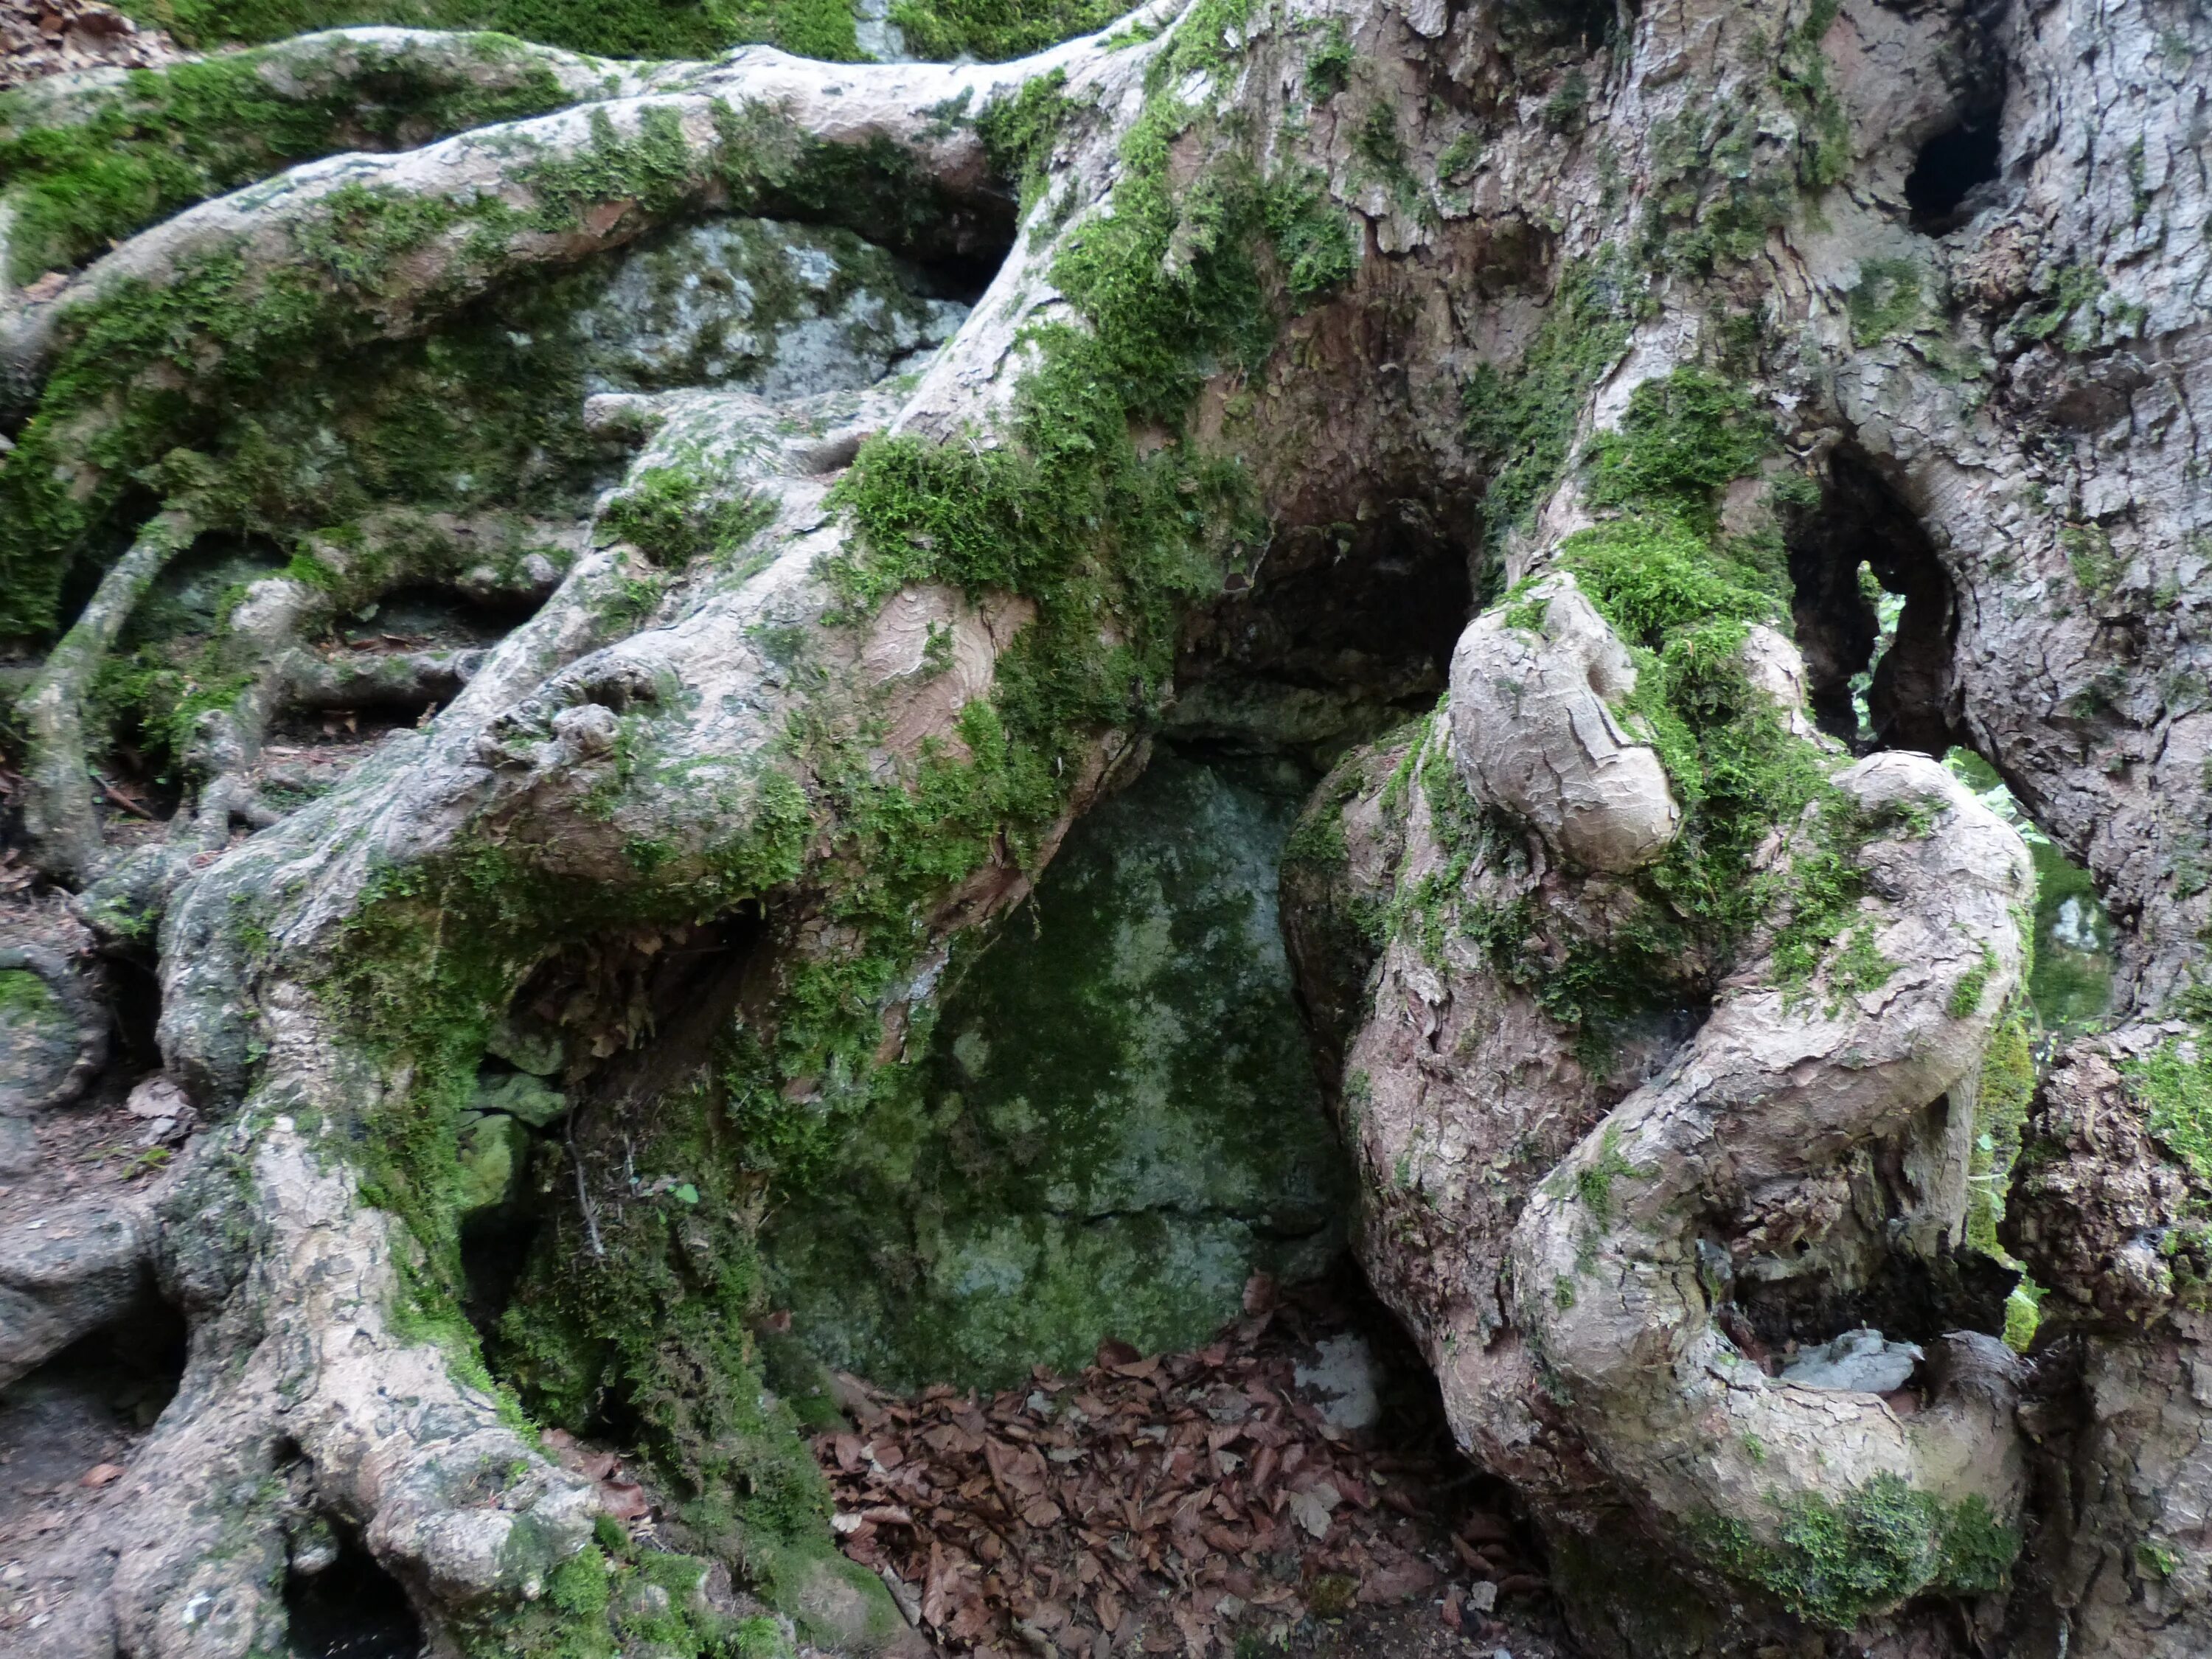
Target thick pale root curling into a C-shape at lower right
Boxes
[1513,754,2033,1626]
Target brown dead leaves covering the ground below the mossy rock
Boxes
[816,1274,1571,1659]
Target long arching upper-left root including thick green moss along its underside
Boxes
[0,38,1097,633]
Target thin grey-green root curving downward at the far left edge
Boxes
[18,509,195,883]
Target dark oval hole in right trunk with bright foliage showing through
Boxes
[1785,449,1962,759]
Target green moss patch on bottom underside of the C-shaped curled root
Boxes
[1690,1475,2020,1630]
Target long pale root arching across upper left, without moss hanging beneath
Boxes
[0,42,1088,405]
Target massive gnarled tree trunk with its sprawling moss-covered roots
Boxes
[0,0,2212,1659]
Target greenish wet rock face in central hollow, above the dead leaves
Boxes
[763,754,1349,1387]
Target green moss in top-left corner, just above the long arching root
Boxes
[0,35,573,283]
